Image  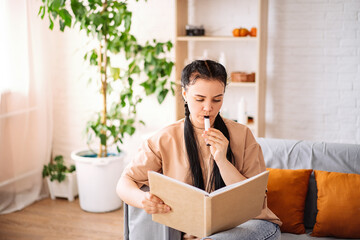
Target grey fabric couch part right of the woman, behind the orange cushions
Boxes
[257,138,360,240]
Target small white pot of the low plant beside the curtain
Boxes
[46,172,78,202]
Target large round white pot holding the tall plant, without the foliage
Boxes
[71,150,125,212]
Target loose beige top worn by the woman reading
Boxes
[122,118,281,225]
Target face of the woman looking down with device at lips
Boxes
[183,78,225,128]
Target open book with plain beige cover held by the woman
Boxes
[148,171,269,238]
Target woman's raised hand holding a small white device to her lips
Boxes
[202,128,229,161]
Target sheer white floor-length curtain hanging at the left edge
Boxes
[0,0,52,214]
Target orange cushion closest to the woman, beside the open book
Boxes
[267,168,312,234]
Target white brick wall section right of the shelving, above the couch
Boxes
[266,0,360,143]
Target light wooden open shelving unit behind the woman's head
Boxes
[175,0,268,137]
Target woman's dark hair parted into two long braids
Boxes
[181,60,234,191]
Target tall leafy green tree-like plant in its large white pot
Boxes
[39,0,174,212]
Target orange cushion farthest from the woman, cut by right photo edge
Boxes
[311,170,360,238]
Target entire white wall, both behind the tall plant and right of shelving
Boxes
[45,0,360,165]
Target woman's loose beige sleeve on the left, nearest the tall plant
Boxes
[122,140,162,188]
